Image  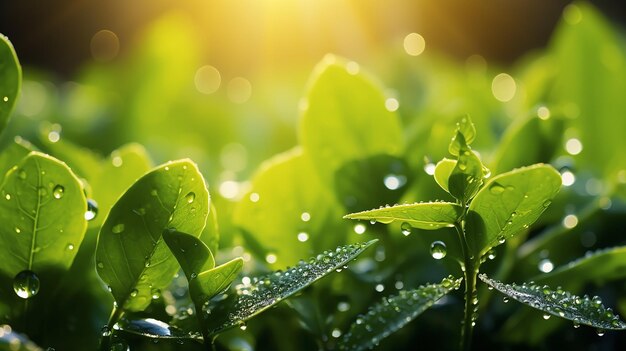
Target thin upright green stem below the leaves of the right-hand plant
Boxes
[455,223,478,351]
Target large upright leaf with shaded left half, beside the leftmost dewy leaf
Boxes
[96,160,209,311]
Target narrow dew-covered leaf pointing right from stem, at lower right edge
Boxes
[479,274,626,330]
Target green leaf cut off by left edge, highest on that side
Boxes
[0,34,22,132]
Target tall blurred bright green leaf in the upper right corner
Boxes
[549,1,626,176]
